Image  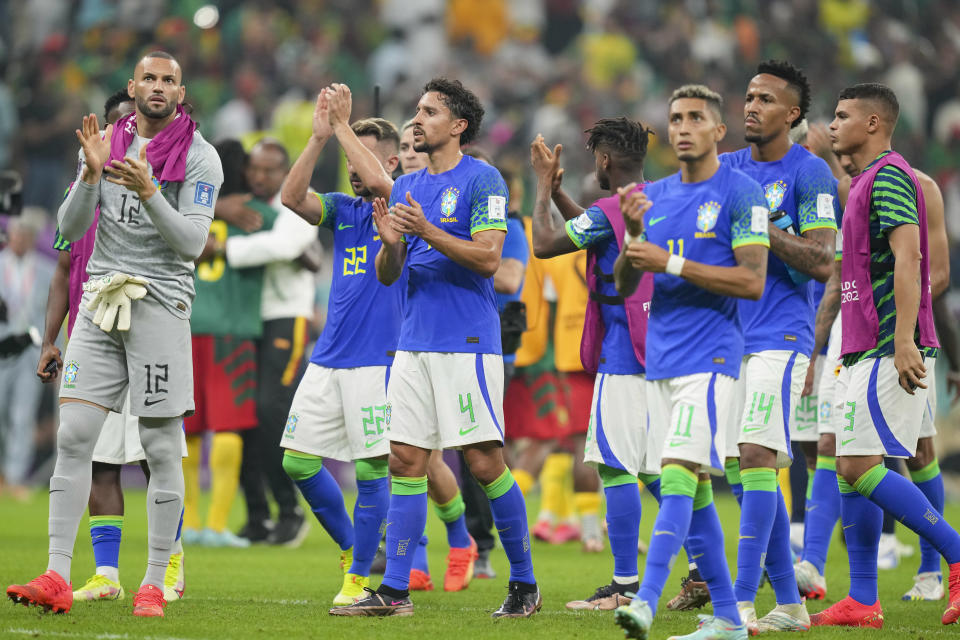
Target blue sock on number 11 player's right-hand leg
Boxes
[688,480,743,625]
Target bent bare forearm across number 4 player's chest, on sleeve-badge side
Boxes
[388,192,507,282]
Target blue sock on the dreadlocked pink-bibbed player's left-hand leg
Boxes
[600,466,641,580]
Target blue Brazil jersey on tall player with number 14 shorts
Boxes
[720,144,840,356]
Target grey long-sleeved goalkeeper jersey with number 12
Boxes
[58,131,223,319]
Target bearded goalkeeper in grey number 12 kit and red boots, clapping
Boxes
[7,51,223,617]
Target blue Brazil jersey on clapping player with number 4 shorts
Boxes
[390,156,508,353]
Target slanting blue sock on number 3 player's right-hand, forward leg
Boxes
[854,465,960,564]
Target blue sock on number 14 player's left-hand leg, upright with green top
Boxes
[740,467,776,602]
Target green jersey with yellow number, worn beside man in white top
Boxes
[190,198,277,338]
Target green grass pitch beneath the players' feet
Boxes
[0,491,960,640]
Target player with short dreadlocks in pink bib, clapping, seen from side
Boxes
[530,117,660,610]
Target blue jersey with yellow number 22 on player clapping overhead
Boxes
[310,193,406,369]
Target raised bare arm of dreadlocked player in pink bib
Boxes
[530,135,583,258]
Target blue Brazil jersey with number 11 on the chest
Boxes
[643,163,770,380]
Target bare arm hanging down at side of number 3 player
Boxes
[888,224,927,395]
